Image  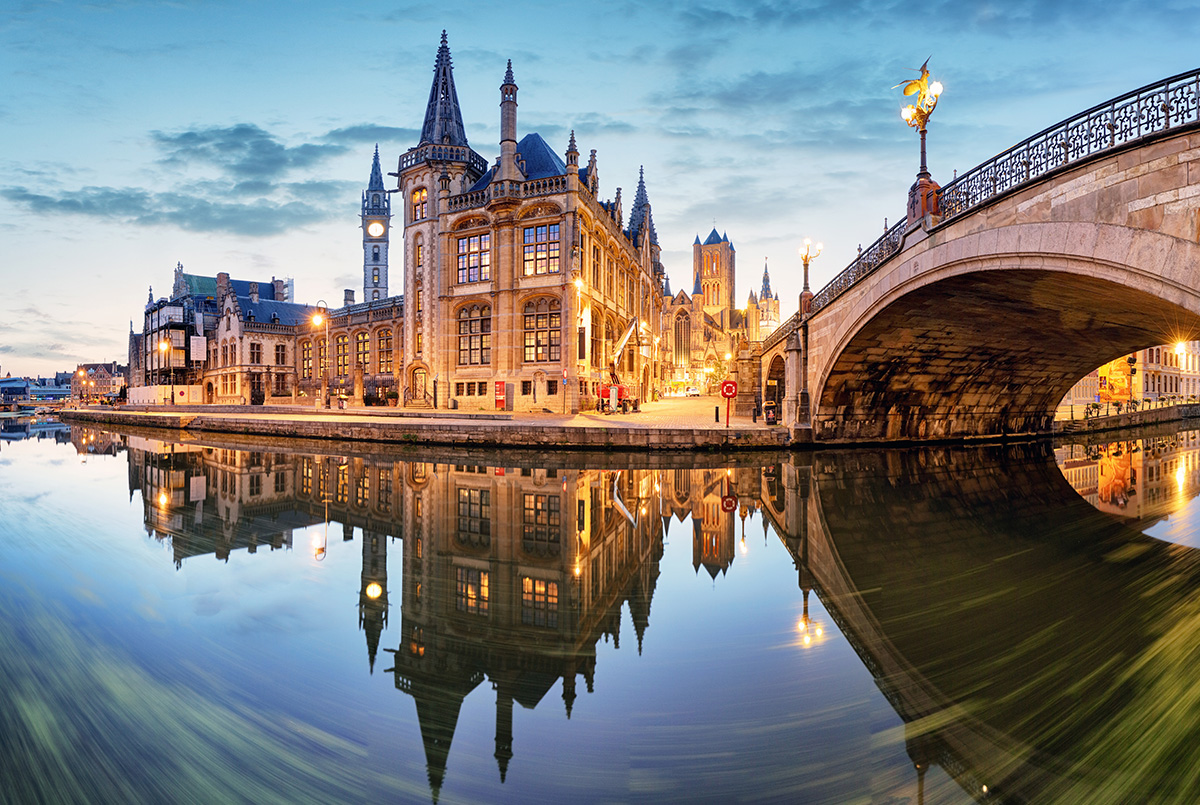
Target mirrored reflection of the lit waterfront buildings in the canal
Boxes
[117,432,779,799]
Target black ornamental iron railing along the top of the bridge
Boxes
[811,70,1200,313]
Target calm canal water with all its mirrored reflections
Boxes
[7,420,1200,804]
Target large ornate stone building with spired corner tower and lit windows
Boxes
[396,32,662,411]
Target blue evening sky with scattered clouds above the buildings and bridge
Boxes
[0,0,1200,376]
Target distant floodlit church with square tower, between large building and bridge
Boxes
[662,227,779,391]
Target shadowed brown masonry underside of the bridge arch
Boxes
[812,269,1200,441]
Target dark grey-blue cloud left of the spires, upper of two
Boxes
[151,124,347,179]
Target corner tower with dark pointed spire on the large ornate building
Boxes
[392,31,490,405]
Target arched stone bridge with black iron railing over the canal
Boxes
[762,71,1200,443]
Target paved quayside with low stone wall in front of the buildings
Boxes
[60,397,810,451]
